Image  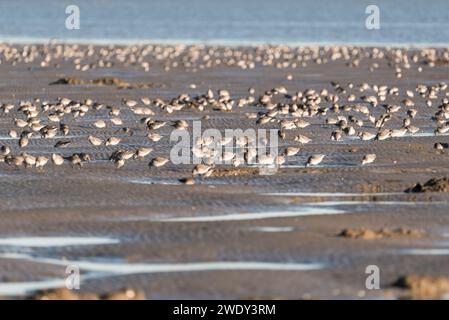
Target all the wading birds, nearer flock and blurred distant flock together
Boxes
[0,44,449,183]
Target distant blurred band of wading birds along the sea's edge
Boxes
[0,43,449,71]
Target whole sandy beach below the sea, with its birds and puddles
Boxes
[0,44,449,299]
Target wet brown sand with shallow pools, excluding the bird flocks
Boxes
[0,46,449,299]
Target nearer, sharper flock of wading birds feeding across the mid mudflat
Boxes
[0,83,449,183]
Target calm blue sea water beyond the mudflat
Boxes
[0,0,449,46]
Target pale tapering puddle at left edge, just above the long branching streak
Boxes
[0,237,120,248]
